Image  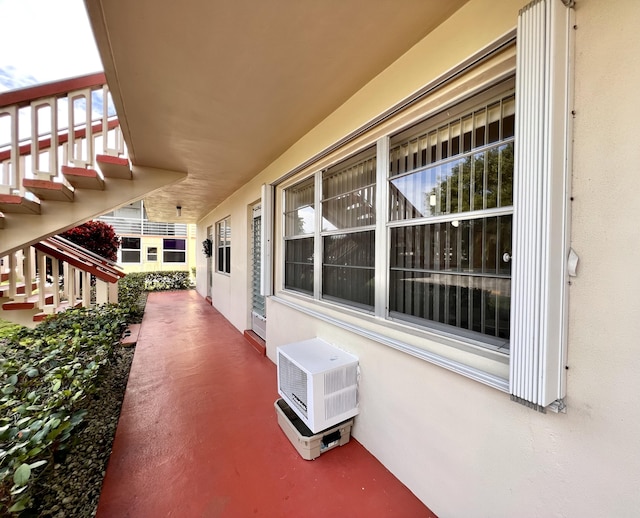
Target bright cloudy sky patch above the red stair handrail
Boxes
[0,0,102,92]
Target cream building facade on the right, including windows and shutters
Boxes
[192,0,640,517]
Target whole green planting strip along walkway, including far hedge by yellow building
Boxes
[0,272,190,516]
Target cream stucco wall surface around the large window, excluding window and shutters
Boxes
[198,0,640,518]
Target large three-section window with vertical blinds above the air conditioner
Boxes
[284,85,515,352]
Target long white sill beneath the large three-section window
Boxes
[269,292,509,392]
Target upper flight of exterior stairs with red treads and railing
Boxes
[0,74,185,257]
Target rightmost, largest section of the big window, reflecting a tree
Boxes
[389,86,515,346]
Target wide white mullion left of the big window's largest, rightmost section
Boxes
[374,137,389,318]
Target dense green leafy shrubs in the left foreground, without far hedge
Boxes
[0,305,129,515]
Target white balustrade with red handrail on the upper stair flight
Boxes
[0,73,125,198]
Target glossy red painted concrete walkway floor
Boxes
[97,291,435,518]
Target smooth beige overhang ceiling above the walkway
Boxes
[86,0,467,222]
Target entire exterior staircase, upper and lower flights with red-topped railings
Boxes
[0,73,185,324]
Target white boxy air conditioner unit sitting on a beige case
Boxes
[277,338,358,433]
